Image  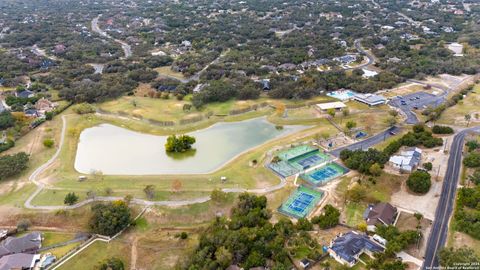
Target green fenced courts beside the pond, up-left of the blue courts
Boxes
[268,145,330,177]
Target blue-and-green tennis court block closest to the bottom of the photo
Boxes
[278,186,323,218]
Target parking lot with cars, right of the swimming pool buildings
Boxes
[389,91,445,124]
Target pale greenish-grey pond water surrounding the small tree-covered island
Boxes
[75,117,308,175]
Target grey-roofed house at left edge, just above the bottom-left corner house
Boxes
[0,232,42,257]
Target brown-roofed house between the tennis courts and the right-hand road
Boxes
[363,202,398,232]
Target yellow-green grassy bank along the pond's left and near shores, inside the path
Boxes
[27,110,335,205]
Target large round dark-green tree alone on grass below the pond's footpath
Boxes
[89,200,131,236]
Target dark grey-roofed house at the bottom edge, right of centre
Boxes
[328,231,385,267]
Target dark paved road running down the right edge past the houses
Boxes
[423,127,480,269]
